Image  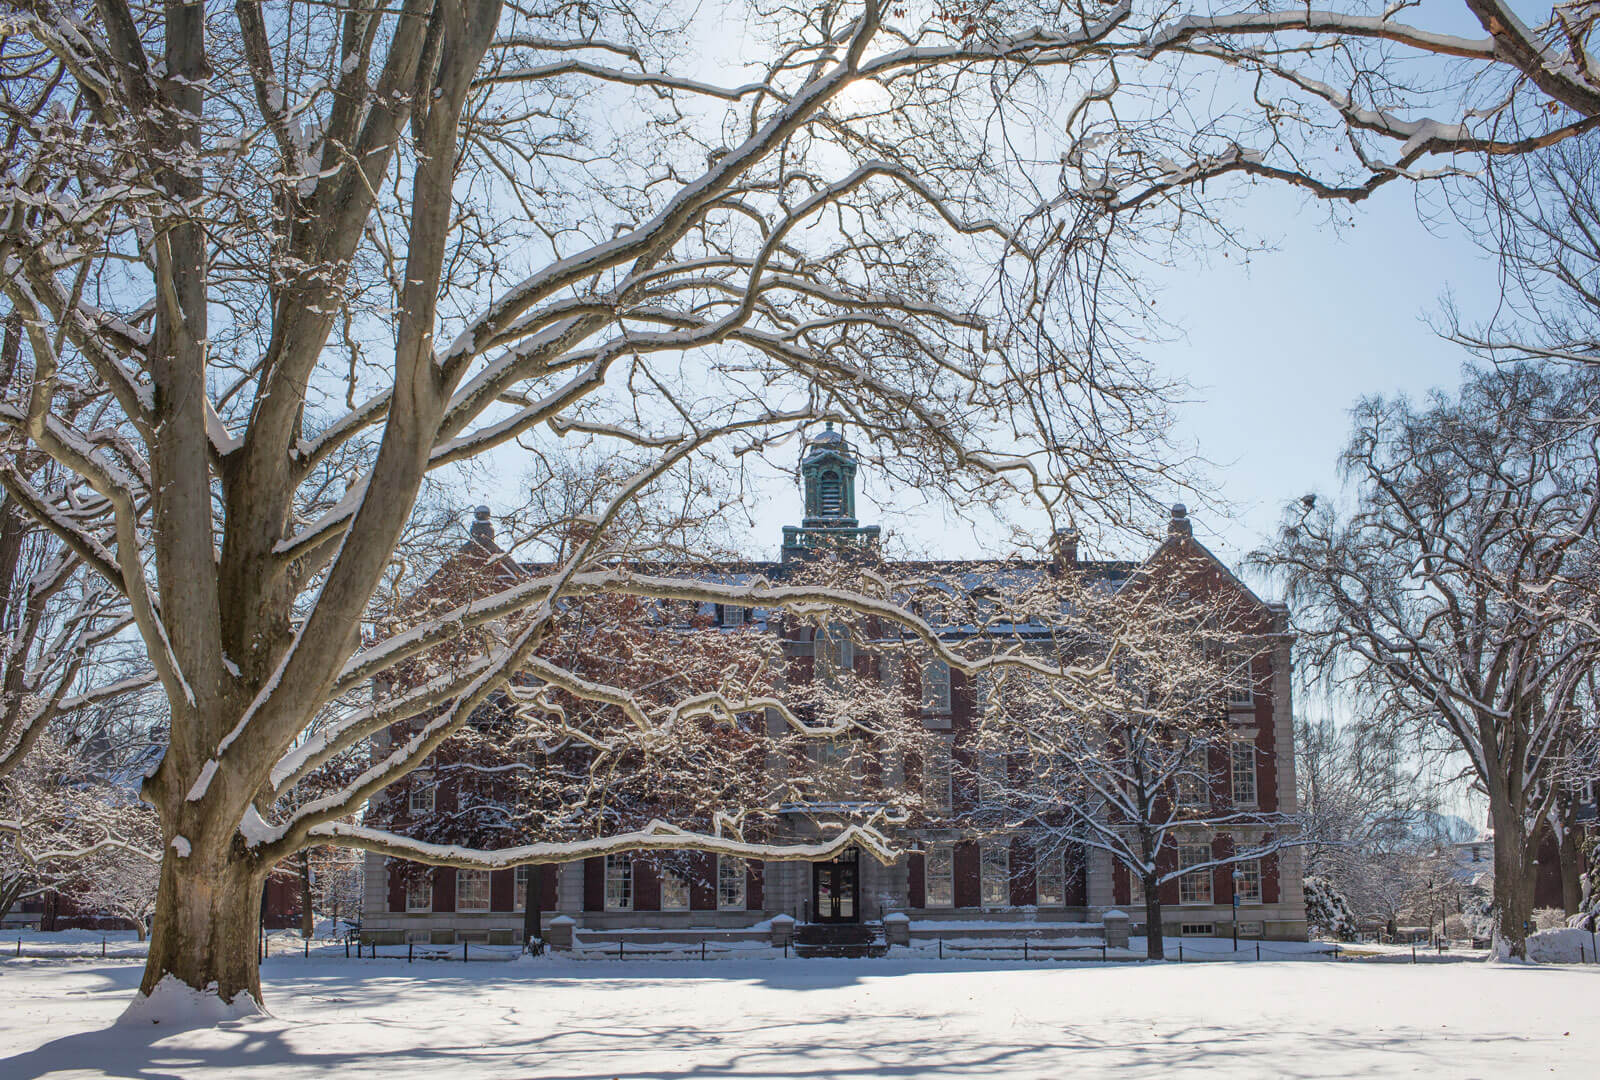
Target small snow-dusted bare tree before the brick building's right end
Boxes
[940,544,1301,958]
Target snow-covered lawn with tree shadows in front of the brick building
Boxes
[0,957,1600,1080]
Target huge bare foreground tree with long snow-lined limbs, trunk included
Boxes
[0,0,1248,1002]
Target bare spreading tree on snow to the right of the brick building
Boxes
[1256,366,1600,955]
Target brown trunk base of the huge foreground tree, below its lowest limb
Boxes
[134,846,261,1010]
